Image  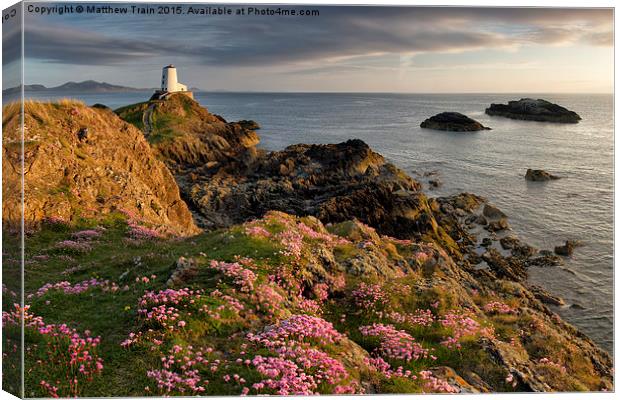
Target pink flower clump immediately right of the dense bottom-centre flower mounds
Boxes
[359,323,434,362]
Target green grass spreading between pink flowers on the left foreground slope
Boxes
[4,219,279,396]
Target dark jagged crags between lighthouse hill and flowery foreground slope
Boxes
[172,140,458,250]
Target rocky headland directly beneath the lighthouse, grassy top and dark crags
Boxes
[116,96,452,252]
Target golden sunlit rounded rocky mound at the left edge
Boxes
[2,101,199,235]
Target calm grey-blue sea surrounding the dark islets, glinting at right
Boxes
[15,93,614,353]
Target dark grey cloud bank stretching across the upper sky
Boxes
[21,6,613,67]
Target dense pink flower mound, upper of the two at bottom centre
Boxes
[248,314,343,348]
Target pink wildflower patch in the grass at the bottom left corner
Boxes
[2,304,103,397]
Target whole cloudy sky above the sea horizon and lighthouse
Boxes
[3,3,614,93]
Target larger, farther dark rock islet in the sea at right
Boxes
[484,98,581,123]
